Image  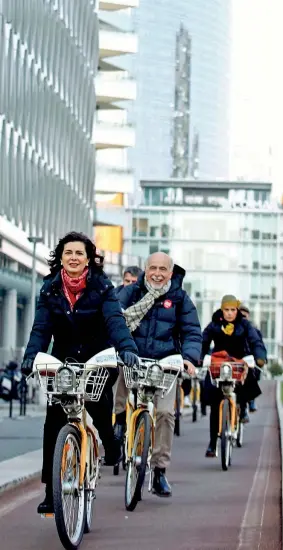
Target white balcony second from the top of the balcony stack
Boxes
[99,28,138,59]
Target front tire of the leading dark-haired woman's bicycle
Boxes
[53,424,85,550]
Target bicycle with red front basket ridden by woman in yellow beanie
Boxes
[207,355,254,471]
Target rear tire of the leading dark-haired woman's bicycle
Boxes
[84,433,98,533]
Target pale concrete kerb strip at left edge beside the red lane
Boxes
[0,449,42,496]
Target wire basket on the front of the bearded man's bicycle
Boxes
[123,360,179,393]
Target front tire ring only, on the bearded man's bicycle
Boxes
[125,411,151,512]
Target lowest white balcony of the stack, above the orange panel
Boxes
[95,164,134,194]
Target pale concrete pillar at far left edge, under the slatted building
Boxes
[3,289,17,352]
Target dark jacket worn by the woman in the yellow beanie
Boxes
[202,309,266,360]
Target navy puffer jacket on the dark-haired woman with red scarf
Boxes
[24,270,137,363]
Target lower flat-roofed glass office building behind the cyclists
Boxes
[124,180,283,355]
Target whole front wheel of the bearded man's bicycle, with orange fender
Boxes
[125,411,151,512]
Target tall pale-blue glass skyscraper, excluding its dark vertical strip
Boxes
[131,0,232,180]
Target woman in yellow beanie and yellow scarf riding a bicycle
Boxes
[202,294,265,457]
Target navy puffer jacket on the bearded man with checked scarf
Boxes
[119,265,202,364]
